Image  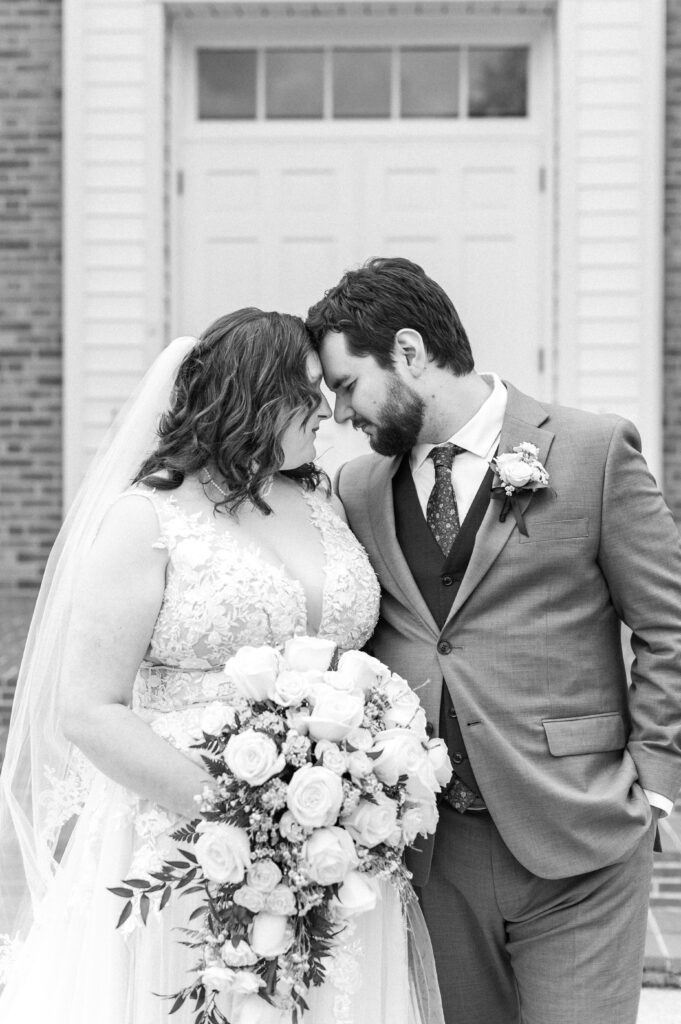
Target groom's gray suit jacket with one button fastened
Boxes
[338,385,681,885]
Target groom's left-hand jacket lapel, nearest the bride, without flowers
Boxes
[367,458,439,635]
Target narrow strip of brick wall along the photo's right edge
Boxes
[664,0,681,523]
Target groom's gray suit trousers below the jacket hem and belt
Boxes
[419,805,655,1024]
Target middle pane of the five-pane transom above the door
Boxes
[334,50,390,118]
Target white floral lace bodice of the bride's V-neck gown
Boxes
[134,488,379,711]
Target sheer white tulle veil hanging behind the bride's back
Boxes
[0,337,197,966]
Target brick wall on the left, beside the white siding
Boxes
[0,0,61,591]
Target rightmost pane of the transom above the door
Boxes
[468,48,528,118]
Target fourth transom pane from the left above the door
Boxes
[400,49,459,118]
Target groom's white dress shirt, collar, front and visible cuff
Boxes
[410,374,674,817]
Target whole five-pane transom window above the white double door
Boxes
[197,46,529,121]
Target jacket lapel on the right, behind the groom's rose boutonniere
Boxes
[445,384,554,626]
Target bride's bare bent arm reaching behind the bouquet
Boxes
[60,496,210,817]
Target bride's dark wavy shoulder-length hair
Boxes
[133,307,328,515]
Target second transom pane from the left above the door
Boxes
[265,50,324,118]
